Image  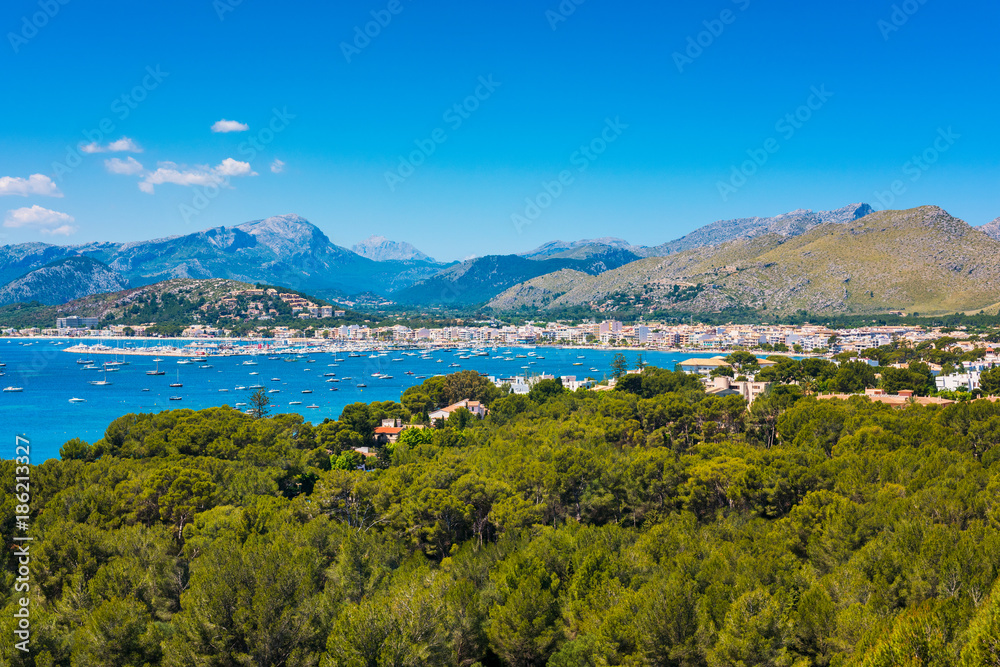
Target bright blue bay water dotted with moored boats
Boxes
[0,338,695,463]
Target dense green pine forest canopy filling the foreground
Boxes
[0,365,1000,667]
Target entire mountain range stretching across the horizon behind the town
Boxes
[0,204,1000,312]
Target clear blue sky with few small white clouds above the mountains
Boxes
[0,0,1000,260]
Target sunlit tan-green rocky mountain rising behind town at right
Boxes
[489,206,1000,314]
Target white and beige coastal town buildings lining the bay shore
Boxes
[4,318,1000,404]
